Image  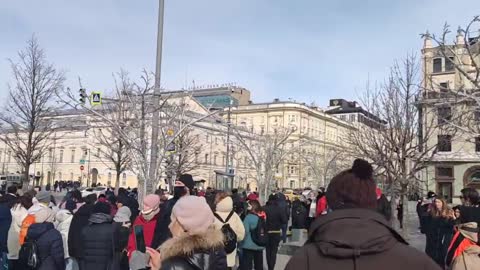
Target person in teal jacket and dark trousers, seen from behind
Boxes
[240,200,265,270]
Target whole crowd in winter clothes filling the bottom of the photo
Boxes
[0,159,480,270]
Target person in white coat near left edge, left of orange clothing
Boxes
[8,195,33,269]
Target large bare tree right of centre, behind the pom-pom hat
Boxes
[349,55,454,235]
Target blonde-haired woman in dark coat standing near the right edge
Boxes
[425,198,455,269]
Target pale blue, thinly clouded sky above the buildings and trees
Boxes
[0,0,480,107]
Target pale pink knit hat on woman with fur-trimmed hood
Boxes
[172,196,215,235]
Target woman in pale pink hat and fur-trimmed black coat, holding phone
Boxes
[147,196,227,270]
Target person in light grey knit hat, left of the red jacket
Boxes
[113,206,132,270]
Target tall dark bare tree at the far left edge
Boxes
[0,37,65,190]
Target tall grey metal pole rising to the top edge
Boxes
[144,0,165,195]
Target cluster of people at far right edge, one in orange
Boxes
[417,188,480,270]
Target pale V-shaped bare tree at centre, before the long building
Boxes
[233,127,296,199]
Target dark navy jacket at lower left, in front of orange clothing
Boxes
[21,222,65,270]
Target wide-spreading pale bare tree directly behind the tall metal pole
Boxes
[59,70,217,201]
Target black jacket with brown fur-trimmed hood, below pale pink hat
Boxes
[160,227,227,270]
